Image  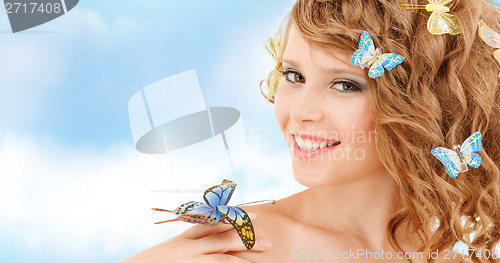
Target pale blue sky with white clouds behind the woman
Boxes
[0,0,303,263]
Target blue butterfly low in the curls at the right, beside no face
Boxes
[431,132,482,178]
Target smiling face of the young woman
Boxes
[274,26,385,187]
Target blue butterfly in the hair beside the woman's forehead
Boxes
[351,31,405,79]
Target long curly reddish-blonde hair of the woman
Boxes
[261,0,500,262]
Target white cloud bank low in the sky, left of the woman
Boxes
[0,135,297,262]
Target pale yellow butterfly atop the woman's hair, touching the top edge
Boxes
[401,0,460,35]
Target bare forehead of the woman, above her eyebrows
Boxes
[283,24,366,76]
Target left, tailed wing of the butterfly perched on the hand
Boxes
[153,201,222,224]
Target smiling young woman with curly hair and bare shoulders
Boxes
[123,0,500,263]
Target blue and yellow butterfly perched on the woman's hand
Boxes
[152,180,255,249]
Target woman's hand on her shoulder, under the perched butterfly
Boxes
[121,213,271,263]
